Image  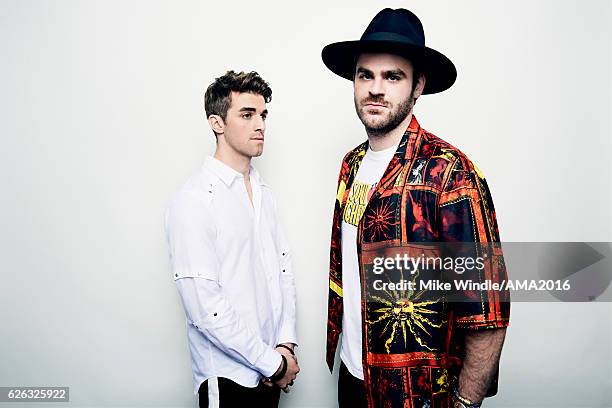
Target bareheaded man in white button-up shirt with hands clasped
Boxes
[165,71,299,407]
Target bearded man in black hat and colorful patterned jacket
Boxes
[322,9,510,408]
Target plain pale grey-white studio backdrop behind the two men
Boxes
[0,0,612,407]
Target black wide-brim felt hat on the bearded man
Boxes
[321,8,457,94]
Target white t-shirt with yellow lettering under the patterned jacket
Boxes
[340,145,397,380]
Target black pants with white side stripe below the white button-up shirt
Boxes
[198,377,280,408]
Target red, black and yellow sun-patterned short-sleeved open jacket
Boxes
[327,116,510,408]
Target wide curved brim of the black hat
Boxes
[321,40,457,95]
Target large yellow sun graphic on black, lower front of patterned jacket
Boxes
[367,272,446,353]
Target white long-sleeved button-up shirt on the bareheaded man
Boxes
[165,157,297,394]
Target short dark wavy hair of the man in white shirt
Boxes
[204,71,272,120]
